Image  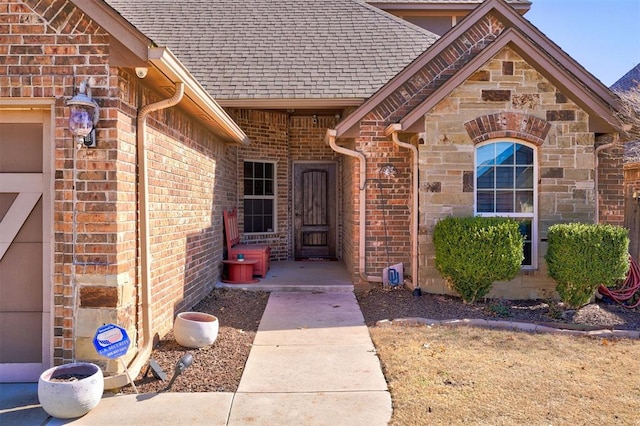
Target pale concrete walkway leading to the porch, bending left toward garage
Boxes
[0,292,391,426]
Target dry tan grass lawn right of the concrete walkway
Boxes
[370,326,640,426]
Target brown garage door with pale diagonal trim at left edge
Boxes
[0,109,52,382]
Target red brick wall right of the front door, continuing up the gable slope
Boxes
[339,15,504,286]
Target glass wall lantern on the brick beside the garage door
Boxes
[67,80,100,147]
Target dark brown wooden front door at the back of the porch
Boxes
[293,163,337,259]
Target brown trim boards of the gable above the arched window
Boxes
[335,0,616,137]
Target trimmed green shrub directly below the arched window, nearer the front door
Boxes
[433,217,524,303]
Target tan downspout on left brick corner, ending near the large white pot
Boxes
[104,82,184,389]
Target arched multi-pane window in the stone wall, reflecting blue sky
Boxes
[475,141,538,268]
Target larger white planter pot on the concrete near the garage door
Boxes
[38,362,104,419]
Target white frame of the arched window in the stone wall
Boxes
[473,138,539,270]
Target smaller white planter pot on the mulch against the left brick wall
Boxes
[173,312,218,348]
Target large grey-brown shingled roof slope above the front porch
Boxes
[106,0,437,100]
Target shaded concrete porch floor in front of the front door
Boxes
[216,260,353,292]
